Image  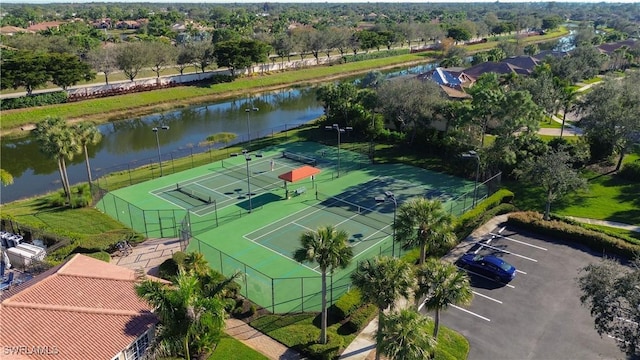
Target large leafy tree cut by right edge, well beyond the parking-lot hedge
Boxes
[578,73,640,171]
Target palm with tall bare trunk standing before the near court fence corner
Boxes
[293,225,353,344]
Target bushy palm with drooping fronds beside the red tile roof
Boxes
[136,270,226,360]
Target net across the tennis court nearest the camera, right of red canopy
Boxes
[316,193,393,230]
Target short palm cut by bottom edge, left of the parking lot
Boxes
[379,309,436,360]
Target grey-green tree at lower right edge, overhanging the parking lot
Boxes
[578,259,640,359]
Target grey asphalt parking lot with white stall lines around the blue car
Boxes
[430,227,625,360]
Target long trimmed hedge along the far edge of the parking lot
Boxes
[507,211,640,259]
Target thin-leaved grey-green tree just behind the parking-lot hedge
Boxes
[515,148,587,220]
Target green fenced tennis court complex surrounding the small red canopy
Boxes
[97,142,488,312]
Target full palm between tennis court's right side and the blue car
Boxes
[394,198,456,264]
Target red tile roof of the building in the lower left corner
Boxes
[0,254,157,360]
